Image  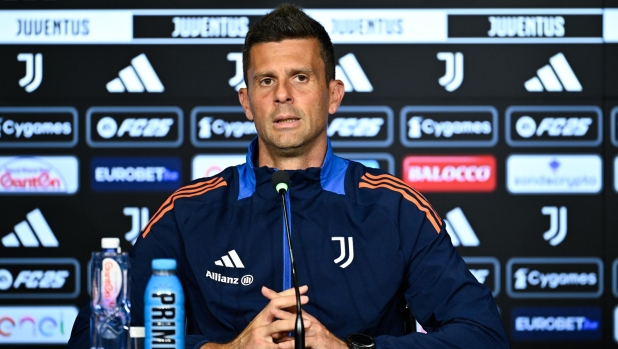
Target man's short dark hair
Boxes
[242,4,335,86]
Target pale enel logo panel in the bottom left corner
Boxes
[0,305,78,345]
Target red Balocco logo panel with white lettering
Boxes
[403,155,496,192]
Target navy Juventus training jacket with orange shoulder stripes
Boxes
[70,140,508,349]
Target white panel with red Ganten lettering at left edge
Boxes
[0,156,79,195]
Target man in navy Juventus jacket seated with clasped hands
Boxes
[74,5,508,349]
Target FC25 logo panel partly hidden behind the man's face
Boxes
[326,106,394,148]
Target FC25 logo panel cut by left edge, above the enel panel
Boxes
[0,258,80,299]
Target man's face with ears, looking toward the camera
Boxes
[239,39,343,156]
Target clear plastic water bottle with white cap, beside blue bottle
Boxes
[90,238,131,349]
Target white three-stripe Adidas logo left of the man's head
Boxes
[105,53,165,93]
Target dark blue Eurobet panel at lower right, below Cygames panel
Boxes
[511,307,601,341]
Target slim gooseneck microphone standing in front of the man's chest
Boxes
[272,170,305,349]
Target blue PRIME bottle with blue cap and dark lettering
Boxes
[144,259,185,349]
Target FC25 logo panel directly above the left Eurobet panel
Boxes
[86,107,183,148]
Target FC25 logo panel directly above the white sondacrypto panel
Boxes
[506,106,603,147]
